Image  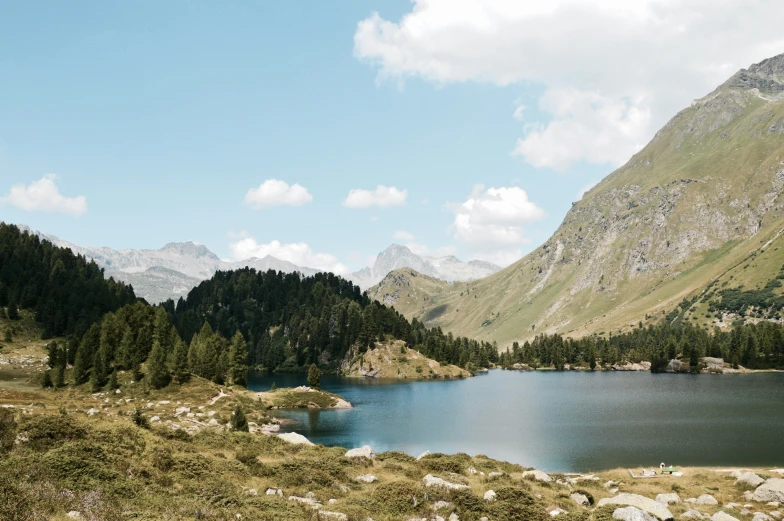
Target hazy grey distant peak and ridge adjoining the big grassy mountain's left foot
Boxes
[349,244,501,289]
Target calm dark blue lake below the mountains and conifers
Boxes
[248,370,784,472]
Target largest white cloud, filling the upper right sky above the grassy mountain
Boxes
[354,0,784,169]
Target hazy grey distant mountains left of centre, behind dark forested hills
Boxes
[19,225,319,303]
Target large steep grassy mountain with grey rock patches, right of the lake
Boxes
[369,55,784,346]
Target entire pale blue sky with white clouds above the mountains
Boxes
[0,0,784,274]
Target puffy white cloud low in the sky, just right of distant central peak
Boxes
[450,185,544,265]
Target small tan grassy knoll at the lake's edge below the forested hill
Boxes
[344,340,471,380]
